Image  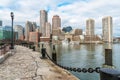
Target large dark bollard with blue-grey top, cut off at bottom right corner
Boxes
[100,68,120,80]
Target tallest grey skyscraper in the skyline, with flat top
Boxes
[40,10,47,37]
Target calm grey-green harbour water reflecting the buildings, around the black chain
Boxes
[45,44,120,80]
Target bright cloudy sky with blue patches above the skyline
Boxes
[0,0,120,36]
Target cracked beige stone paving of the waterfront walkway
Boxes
[0,46,79,80]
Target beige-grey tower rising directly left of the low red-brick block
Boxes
[25,21,33,41]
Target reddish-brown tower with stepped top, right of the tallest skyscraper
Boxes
[52,15,61,30]
